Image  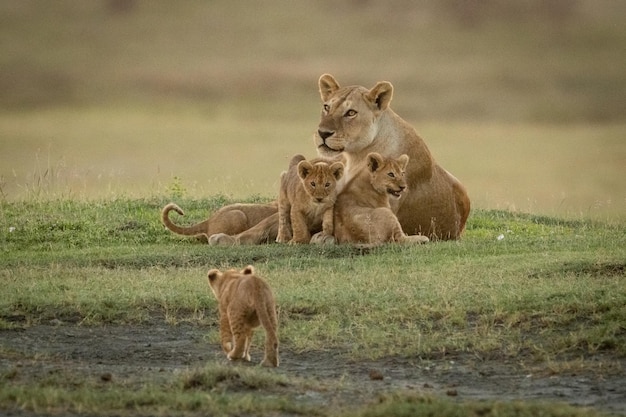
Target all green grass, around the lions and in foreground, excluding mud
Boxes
[0,196,626,416]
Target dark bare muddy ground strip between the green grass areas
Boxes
[0,323,626,415]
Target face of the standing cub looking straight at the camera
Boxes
[298,161,344,203]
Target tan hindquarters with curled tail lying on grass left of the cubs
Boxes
[161,203,278,241]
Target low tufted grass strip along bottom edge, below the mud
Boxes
[0,365,605,417]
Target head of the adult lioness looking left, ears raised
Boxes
[314,74,393,157]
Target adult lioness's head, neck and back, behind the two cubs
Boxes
[314,74,470,239]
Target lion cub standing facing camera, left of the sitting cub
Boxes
[276,155,344,243]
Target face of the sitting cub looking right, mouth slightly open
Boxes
[367,152,409,198]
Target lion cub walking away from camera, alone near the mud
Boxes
[208,265,278,366]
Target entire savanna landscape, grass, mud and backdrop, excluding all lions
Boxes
[0,0,626,416]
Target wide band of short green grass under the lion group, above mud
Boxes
[0,197,626,360]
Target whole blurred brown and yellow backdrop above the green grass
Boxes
[0,0,626,219]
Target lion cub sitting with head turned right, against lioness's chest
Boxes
[335,152,428,245]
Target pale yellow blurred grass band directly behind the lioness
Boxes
[0,108,626,220]
